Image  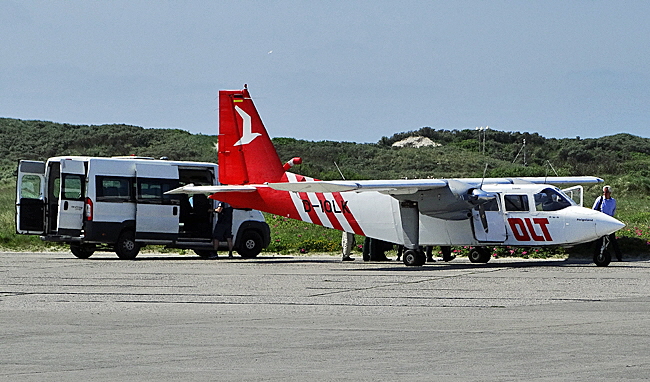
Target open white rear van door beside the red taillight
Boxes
[56,159,86,236]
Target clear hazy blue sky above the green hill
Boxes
[0,0,650,142]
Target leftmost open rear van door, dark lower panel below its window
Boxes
[16,160,45,235]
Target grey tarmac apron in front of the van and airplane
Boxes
[0,253,650,381]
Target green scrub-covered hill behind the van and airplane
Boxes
[0,118,650,253]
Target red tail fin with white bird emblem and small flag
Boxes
[218,88,285,185]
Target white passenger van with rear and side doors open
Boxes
[16,156,270,259]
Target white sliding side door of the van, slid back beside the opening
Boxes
[135,163,180,241]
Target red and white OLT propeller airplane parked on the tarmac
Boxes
[169,86,625,266]
